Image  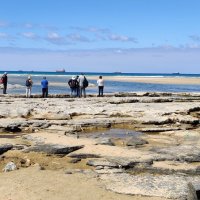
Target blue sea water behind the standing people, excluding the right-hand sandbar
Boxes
[0,71,200,94]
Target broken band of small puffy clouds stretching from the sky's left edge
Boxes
[0,21,137,45]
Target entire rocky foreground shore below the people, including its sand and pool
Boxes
[0,93,200,200]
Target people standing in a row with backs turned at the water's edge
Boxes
[1,72,104,98]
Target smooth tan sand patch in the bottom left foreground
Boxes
[0,167,166,200]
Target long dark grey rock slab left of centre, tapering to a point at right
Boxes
[25,144,84,154]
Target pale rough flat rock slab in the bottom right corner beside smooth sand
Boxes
[100,173,200,199]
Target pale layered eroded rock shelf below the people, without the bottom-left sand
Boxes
[0,93,200,199]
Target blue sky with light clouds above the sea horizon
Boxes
[0,0,200,73]
